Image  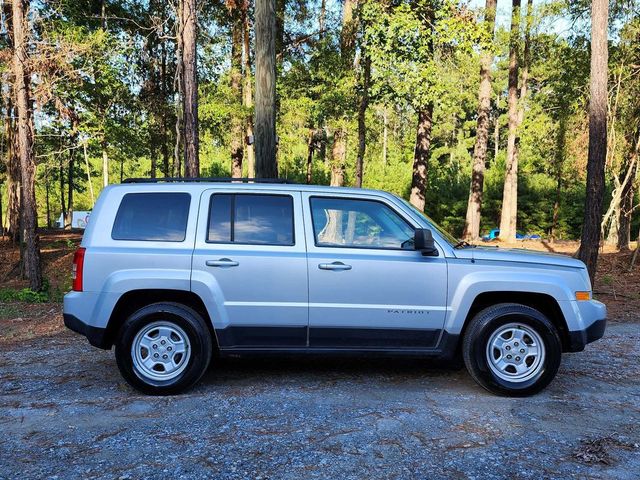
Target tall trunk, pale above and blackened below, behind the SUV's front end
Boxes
[578,0,609,283]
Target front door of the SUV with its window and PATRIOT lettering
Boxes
[303,193,447,349]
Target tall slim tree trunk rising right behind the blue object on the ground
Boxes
[500,0,520,241]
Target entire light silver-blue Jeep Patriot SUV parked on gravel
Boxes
[64,180,606,396]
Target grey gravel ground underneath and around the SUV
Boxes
[0,323,640,480]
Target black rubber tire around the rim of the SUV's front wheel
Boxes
[462,303,562,397]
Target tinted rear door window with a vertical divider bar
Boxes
[207,194,294,246]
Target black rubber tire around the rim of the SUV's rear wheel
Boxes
[115,302,213,395]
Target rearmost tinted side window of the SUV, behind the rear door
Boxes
[111,193,191,242]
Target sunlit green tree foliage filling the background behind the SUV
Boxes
[6,0,640,246]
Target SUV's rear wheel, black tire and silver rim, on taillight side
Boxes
[115,302,213,395]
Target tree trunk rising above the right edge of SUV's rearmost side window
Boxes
[181,0,200,178]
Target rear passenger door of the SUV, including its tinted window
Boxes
[192,188,308,348]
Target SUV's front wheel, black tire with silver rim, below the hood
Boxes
[462,303,562,396]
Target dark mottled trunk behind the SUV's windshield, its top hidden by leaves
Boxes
[409,107,433,212]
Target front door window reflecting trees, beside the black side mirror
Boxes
[311,197,414,250]
